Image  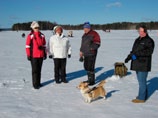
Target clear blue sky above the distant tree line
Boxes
[0,0,158,28]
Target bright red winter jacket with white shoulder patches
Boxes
[26,32,46,58]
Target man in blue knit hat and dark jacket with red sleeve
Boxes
[80,22,101,85]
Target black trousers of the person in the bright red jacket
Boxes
[31,58,43,88]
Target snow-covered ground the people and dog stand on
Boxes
[0,30,158,118]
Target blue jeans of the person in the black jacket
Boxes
[136,71,148,100]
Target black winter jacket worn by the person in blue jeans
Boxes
[130,34,155,72]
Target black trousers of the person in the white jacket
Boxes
[54,58,66,82]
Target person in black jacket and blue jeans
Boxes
[125,25,155,103]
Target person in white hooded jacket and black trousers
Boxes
[48,26,71,84]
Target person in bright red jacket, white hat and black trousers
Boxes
[26,21,47,89]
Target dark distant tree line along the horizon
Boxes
[12,21,158,30]
